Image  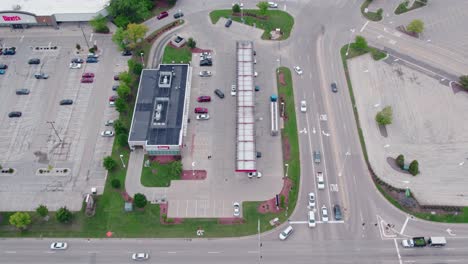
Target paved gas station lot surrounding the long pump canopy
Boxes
[167,19,283,217]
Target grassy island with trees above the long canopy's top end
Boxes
[210,9,294,40]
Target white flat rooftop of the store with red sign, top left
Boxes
[0,0,109,16]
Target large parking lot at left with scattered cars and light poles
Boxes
[0,25,128,211]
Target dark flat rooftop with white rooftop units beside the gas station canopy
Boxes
[129,64,189,145]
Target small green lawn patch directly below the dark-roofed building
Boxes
[141,157,180,187]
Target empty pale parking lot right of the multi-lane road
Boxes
[349,55,468,206]
